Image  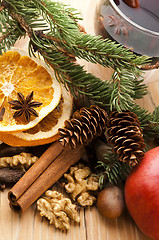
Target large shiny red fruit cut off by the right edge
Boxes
[125,147,159,240]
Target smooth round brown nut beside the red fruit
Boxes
[97,186,124,218]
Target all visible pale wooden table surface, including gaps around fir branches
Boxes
[0,0,159,240]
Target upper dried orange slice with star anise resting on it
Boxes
[0,48,61,132]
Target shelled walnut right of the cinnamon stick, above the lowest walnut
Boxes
[64,163,99,206]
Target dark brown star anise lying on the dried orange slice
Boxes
[8,91,42,122]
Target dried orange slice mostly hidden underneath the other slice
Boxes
[0,87,73,147]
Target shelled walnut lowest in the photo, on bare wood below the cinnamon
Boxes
[37,190,80,230]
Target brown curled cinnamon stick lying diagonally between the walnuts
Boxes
[8,142,85,213]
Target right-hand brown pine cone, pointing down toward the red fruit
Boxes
[107,111,145,166]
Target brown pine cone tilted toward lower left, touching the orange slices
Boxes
[58,105,107,148]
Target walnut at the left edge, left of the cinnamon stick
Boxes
[0,152,38,169]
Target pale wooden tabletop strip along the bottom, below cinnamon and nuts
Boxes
[0,189,152,240]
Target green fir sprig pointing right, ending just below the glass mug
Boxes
[71,34,147,70]
